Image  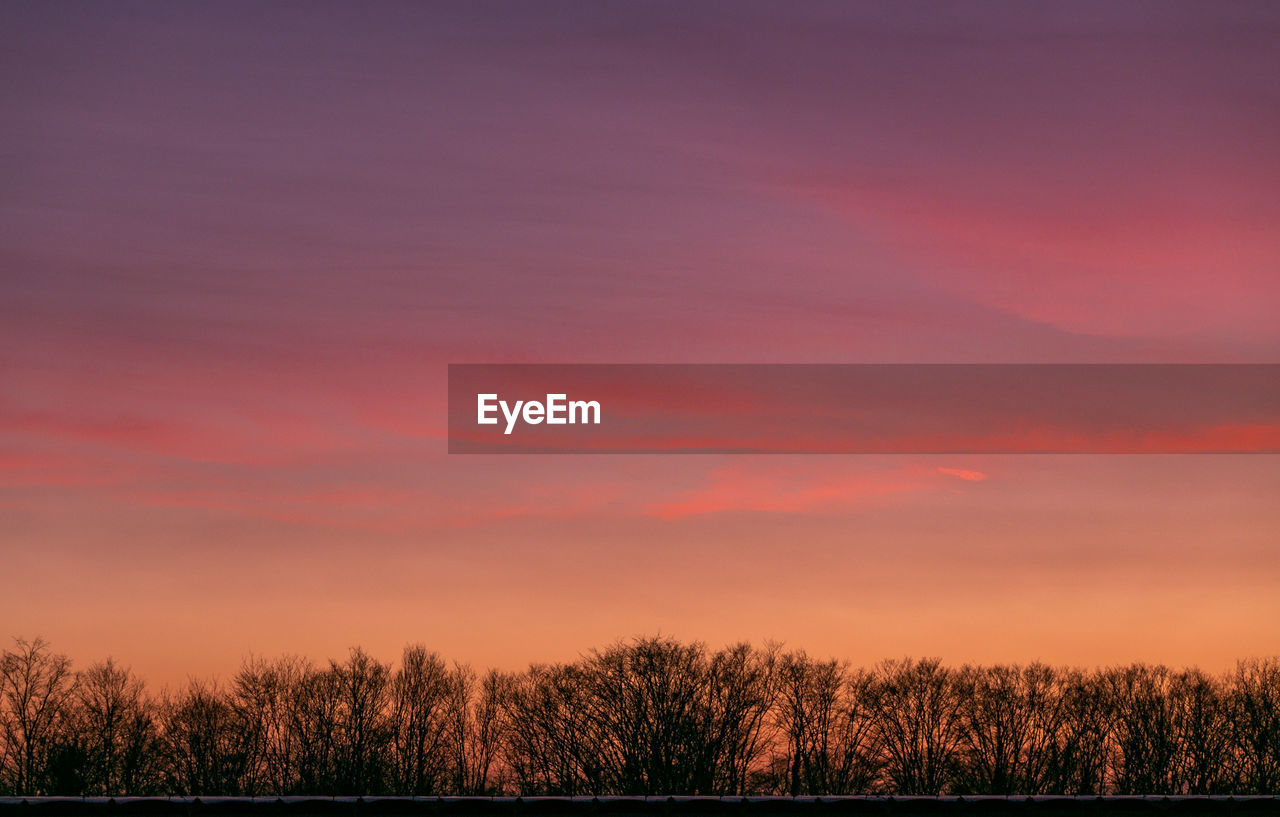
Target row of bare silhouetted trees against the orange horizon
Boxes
[0,636,1280,797]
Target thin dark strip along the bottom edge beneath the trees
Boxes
[0,797,1280,817]
